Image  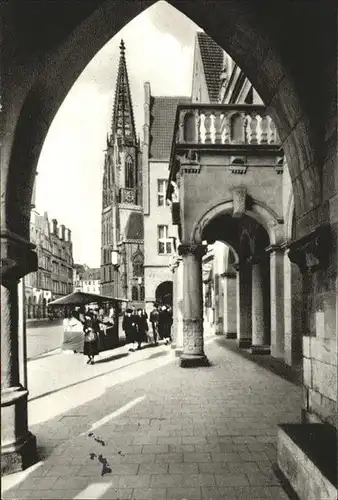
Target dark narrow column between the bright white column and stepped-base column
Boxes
[234,261,252,349]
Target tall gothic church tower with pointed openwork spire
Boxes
[101,40,144,305]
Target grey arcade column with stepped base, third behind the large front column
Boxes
[251,261,270,354]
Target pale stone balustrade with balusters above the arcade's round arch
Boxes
[174,104,280,146]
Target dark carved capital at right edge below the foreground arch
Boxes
[288,226,332,273]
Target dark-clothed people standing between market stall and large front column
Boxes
[122,304,173,351]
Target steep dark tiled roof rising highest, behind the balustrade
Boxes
[197,31,224,102]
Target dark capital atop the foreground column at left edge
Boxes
[0,229,38,284]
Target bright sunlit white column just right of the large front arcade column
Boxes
[221,273,237,339]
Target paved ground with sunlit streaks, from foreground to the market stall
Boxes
[2,337,301,500]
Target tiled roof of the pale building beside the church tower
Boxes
[149,96,191,161]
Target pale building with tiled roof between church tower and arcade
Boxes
[142,82,190,312]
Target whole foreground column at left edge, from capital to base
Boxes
[1,236,37,474]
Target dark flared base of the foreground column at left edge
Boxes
[1,432,38,476]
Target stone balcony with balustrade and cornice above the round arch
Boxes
[167,104,284,204]
